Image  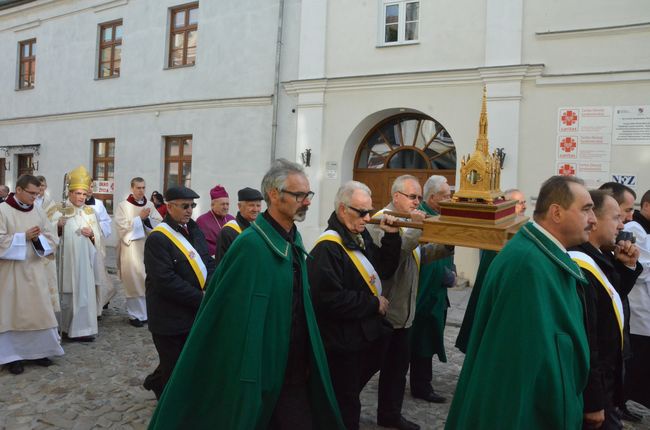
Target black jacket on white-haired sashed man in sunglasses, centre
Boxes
[307,213,402,351]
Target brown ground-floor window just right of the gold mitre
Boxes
[93,139,115,215]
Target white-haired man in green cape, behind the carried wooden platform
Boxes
[410,175,456,403]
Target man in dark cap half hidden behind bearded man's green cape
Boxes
[214,187,264,264]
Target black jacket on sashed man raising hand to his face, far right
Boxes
[572,242,643,412]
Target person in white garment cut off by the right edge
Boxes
[625,191,650,414]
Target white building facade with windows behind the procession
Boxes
[0,0,650,277]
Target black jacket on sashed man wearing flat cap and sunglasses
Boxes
[144,215,215,336]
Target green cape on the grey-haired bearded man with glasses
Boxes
[149,215,344,430]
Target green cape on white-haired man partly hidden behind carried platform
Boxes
[409,202,454,363]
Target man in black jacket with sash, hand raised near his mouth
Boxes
[571,190,642,430]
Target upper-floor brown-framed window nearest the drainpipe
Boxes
[168,3,199,67]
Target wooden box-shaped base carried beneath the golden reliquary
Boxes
[420,216,528,251]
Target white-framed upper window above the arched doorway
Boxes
[381,0,420,45]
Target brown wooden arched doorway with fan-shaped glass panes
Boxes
[353,113,456,209]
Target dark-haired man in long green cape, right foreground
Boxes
[445,176,595,430]
